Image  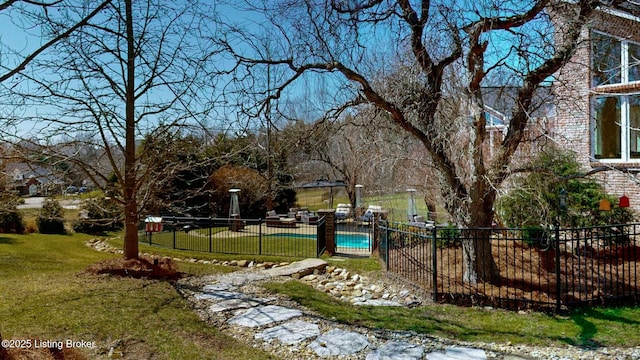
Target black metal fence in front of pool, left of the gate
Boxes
[140,217,326,257]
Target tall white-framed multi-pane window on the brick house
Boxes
[591,32,640,161]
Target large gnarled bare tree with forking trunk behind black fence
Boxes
[222,0,601,283]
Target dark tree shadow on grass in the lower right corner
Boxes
[570,308,640,348]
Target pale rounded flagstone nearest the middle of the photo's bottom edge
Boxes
[308,329,369,357]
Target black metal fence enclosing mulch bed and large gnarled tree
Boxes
[379,222,640,312]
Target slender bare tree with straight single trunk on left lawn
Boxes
[3,0,221,258]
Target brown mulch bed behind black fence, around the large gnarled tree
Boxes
[388,241,640,309]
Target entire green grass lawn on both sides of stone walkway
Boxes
[0,234,640,359]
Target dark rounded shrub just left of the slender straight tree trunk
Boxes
[73,197,123,234]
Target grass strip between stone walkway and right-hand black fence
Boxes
[267,282,640,347]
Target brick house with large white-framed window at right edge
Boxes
[552,1,640,211]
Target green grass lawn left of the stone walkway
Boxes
[0,234,272,359]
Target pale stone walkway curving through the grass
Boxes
[172,259,640,360]
